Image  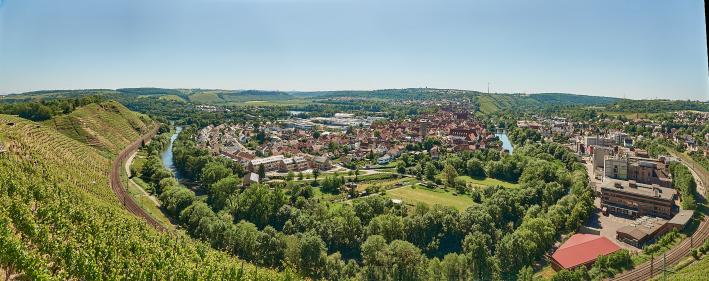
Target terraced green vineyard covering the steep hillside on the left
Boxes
[0,107,290,280]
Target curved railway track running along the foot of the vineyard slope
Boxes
[110,127,165,231]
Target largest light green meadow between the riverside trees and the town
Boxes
[386,186,474,211]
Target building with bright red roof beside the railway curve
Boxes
[551,234,620,270]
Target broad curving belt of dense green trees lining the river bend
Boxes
[160,128,592,280]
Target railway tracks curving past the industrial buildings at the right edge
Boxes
[613,156,709,280]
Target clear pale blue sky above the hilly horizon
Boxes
[0,0,709,100]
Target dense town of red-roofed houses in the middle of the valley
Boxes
[197,109,499,176]
